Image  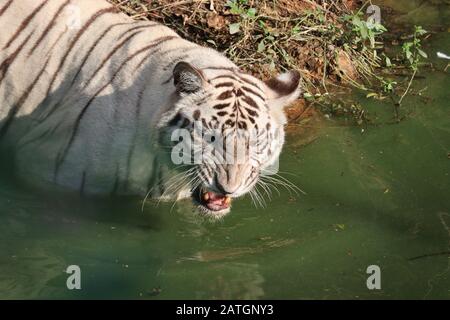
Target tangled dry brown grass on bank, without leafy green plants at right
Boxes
[110,0,373,94]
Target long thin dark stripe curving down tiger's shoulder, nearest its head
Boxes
[55,36,179,174]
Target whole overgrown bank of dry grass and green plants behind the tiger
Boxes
[111,0,426,123]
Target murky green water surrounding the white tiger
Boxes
[0,1,450,299]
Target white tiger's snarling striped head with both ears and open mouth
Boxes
[159,62,300,217]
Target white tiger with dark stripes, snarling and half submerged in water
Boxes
[0,0,300,216]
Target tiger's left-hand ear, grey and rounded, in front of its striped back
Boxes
[173,61,205,93]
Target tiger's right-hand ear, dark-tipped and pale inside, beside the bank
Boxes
[264,70,301,108]
